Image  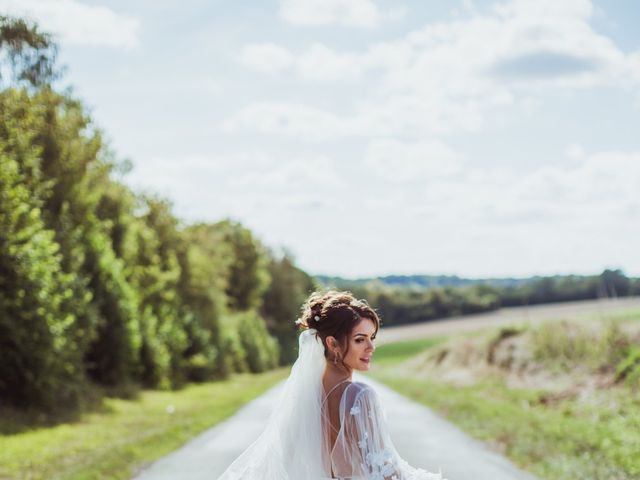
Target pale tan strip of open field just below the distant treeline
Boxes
[378,297,640,345]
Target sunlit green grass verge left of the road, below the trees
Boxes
[0,368,289,480]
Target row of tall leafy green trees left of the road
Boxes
[0,17,314,411]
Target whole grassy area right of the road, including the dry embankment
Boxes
[371,309,640,480]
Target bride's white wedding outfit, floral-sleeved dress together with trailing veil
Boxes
[218,329,446,480]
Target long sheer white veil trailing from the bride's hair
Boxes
[218,328,330,480]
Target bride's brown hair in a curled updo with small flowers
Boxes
[298,290,381,365]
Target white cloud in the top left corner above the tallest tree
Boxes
[0,0,140,48]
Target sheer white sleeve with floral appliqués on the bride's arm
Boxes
[345,386,446,480]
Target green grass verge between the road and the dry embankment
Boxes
[371,316,640,480]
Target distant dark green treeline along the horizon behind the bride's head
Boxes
[319,270,640,326]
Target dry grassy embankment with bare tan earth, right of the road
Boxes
[406,320,640,404]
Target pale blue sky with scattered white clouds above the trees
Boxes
[0,0,640,278]
